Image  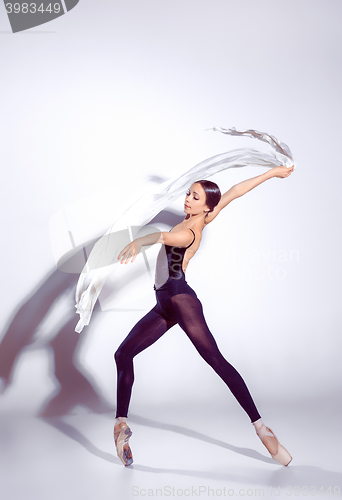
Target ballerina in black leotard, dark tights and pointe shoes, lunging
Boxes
[114,165,294,466]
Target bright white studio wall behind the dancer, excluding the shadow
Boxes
[0,0,342,482]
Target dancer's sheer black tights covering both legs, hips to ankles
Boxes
[115,280,261,422]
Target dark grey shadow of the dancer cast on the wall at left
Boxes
[0,210,184,418]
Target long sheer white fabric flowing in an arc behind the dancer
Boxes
[75,127,295,333]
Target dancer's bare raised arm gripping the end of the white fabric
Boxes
[207,166,294,223]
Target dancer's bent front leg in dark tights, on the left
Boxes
[114,306,176,417]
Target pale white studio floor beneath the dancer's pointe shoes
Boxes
[0,398,342,500]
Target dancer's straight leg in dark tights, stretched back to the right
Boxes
[171,294,260,422]
